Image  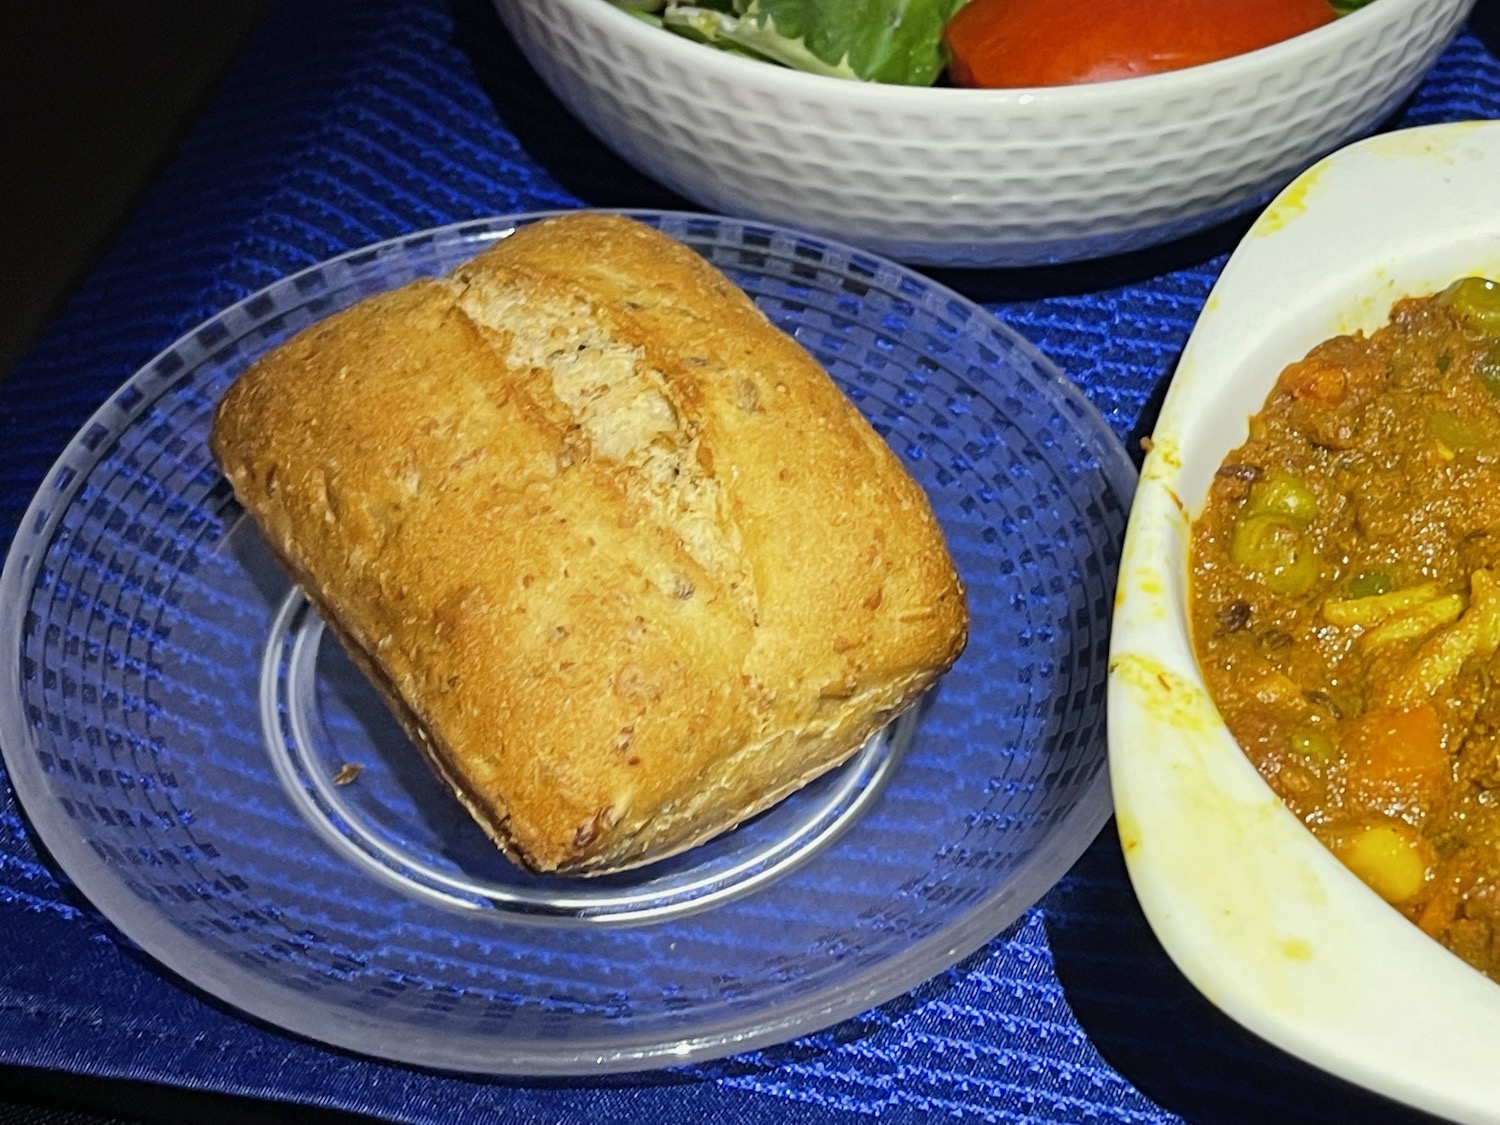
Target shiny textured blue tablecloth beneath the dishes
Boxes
[0,0,1500,1125]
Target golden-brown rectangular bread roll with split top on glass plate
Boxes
[212,212,968,873]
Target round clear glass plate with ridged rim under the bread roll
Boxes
[0,213,1134,1074]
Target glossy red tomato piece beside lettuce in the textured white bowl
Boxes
[945,0,1335,87]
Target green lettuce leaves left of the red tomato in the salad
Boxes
[612,0,968,86]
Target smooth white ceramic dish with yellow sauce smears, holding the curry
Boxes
[1109,122,1500,1124]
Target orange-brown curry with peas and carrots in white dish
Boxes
[1193,278,1500,981]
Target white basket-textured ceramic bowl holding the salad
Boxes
[495,0,1475,266]
